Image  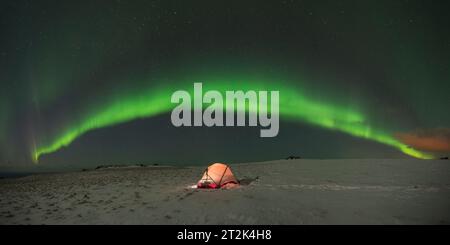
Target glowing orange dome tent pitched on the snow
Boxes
[197,163,239,189]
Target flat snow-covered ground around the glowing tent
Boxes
[0,159,450,224]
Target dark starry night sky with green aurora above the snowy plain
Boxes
[0,0,450,171]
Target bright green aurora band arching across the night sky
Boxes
[31,80,434,163]
